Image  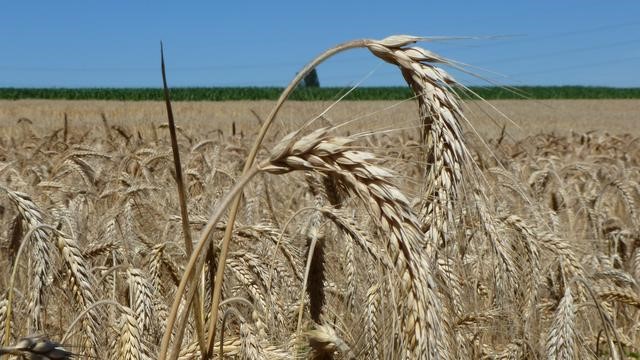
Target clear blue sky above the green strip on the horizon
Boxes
[0,0,640,87]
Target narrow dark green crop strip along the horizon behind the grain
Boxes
[0,86,640,101]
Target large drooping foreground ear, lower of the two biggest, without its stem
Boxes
[262,128,447,358]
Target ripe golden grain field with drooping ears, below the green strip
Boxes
[0,40,640,360]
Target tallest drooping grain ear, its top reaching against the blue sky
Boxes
[367,36,468,250]
